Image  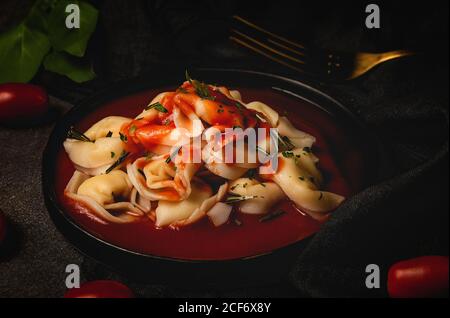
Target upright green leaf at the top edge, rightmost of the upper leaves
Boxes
[48,0,98,57]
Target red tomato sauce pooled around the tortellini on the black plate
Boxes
[55,89,370,260]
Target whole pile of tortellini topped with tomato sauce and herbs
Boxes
[64,84,344,228]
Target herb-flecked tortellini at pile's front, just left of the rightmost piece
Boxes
[229,178,285,214]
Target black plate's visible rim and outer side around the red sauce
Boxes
[42,69,387,288]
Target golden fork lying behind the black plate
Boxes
[229,16,415,80]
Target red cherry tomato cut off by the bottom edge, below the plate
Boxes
[64,280,134,298]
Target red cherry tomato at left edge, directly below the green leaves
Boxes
[0,83,48,123]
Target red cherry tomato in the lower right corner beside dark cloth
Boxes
[388,256,449,298]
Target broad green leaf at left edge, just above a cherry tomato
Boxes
[0,23,50,83]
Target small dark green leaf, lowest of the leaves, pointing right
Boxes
[44,51,95,83]
